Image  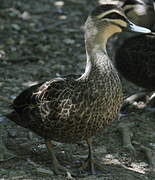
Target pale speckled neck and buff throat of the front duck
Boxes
[82,22,121,79]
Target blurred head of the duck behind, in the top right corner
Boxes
[119,0,155,28]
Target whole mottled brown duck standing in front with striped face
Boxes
[8,5,149,174]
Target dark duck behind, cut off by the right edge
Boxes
[113,0,155,108]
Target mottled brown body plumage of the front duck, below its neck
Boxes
[11,69,121,143]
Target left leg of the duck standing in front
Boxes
[45,140,68,175]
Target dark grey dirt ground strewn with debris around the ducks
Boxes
[0,0,155,180]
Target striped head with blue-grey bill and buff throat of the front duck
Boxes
[85,4,151,51]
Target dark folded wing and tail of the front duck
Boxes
[7,75,80,130]
